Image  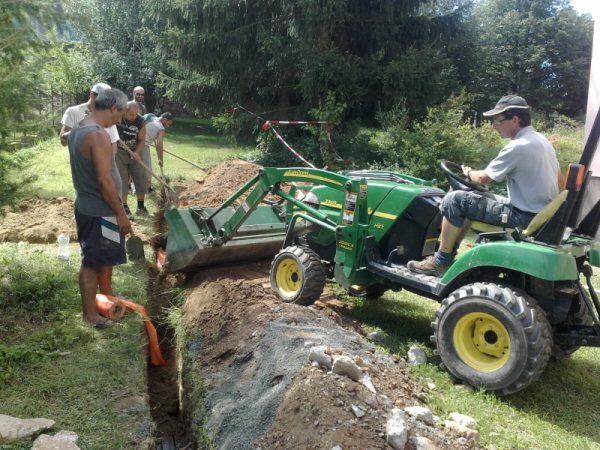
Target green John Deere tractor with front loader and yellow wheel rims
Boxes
[165,110,600,395]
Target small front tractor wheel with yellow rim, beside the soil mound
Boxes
[271,245,325,305]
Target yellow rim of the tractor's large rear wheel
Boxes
[453,312,510,372]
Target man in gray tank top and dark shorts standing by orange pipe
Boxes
[68,89,131,328]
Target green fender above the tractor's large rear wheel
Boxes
[441,241,578,284]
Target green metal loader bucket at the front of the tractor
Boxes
[165,205,286,272]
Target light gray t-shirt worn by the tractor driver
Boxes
[485,126,560,213]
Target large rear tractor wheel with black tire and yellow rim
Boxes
[431,283,552,396]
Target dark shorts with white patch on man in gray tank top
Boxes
[75,210,127,267]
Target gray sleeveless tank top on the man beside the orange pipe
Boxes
[69,125,121,217]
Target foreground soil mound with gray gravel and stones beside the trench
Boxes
[170,262,469,449]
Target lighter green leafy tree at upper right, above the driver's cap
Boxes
[471,0,593,117]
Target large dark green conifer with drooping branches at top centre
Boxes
[149,0,462,120]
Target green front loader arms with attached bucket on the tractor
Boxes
[165,168,368,272]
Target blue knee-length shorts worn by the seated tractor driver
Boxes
[440,191,536,228]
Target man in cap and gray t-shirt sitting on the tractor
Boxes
[408,95,564,276]
